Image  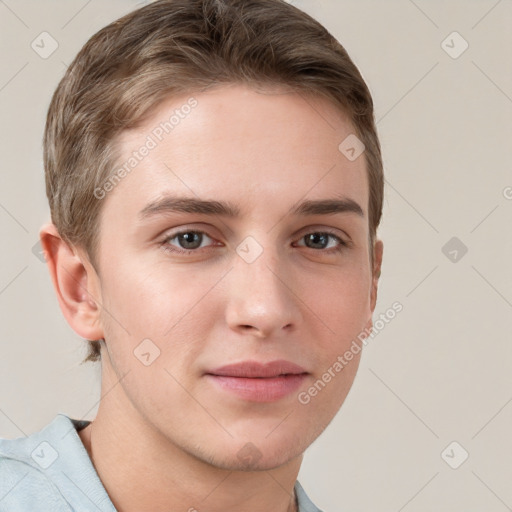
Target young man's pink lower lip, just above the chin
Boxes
[207,373,307,402]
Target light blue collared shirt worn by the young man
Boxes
[0,413,321,512]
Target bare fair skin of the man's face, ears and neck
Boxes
[41,85,383,512]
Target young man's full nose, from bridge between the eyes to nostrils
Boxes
[226,232,299,336]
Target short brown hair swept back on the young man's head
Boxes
[44,0,384,362]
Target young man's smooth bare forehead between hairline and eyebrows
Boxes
[108,85,368,221]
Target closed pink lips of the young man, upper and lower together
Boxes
[205,359,309,402]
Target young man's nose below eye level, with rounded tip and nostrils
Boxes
[226,244,302,339]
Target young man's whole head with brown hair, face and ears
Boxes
[42,0,383,467]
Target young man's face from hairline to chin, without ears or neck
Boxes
[91,85,375,469]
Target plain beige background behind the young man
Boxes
[0,0,512,512]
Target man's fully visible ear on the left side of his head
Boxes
[39,223,104,340]
